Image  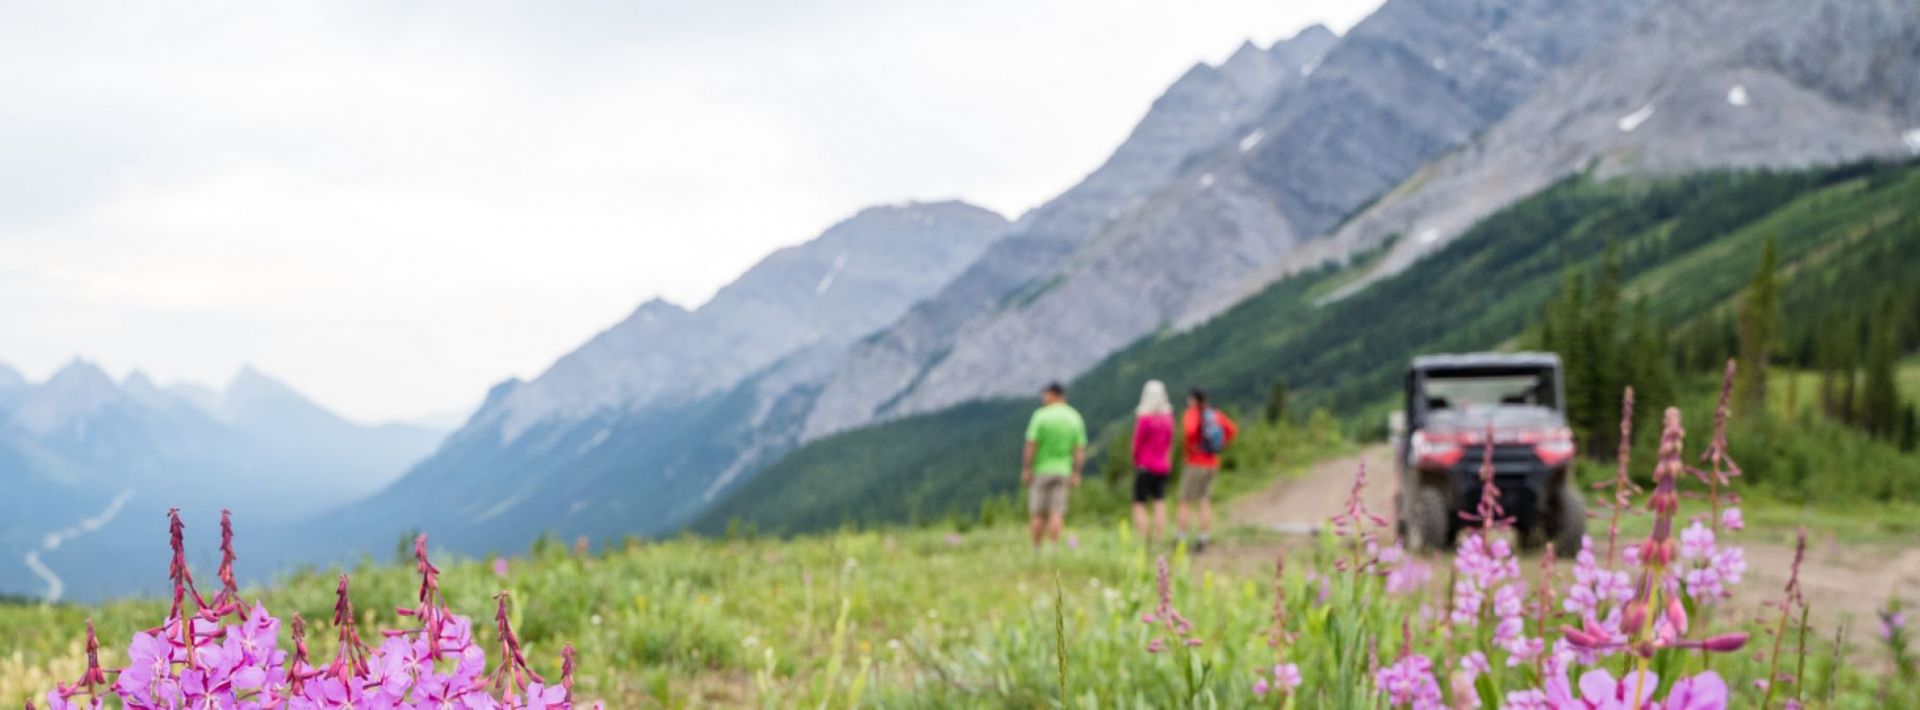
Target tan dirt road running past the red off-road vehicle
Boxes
[1208,445,1920,639]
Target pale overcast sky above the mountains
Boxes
[0,0,1377,420]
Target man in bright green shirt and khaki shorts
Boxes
[1020,382,1087,549]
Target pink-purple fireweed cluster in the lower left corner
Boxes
[41,510,599,710]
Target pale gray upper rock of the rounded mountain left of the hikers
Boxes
[461,201,1008,443]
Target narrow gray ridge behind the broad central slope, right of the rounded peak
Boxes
[803,25,1336,438]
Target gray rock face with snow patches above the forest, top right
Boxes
[1300,0,1920,296]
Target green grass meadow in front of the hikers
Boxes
[11,518,1904,708]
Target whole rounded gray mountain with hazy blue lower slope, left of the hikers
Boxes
[307,201,1008,556]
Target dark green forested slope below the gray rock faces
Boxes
[697,165,1920,532]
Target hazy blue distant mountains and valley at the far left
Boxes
[0,361,445,599]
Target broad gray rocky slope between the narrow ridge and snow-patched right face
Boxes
[806,0,1653,438]
